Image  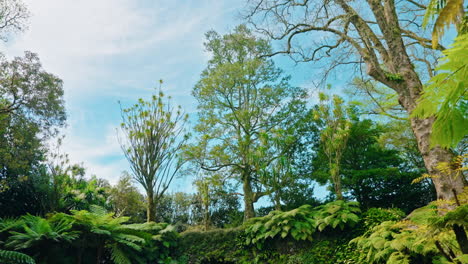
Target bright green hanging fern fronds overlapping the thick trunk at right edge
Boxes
[412,34,468,147]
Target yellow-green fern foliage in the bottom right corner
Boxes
[351,200,466,264]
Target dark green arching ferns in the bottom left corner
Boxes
[0,207,178,264]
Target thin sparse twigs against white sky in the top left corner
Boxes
[0,0,30,41]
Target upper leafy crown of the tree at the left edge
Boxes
[0,51,66,135]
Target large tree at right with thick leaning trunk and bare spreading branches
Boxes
[247,0,466,202]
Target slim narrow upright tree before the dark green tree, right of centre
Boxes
[315,93,351,200]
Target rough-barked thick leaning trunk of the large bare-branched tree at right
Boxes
[338,0,465,200]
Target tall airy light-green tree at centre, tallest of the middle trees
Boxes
[187,25,304,219]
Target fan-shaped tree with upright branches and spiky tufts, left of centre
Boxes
[119,85,188,222]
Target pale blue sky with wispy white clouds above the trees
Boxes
[0,0,328,198]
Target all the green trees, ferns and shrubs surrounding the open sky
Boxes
[0,0,468,264]
